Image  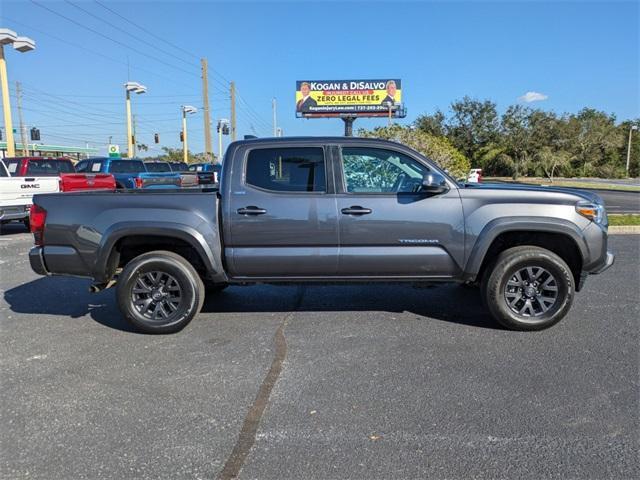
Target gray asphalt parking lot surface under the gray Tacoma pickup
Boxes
[0,225,640,480]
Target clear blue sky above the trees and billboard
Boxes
[0,0,640,155]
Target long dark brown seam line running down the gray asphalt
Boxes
[218,286,305,480]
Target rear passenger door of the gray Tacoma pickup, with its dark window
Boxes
[223,143,338,278]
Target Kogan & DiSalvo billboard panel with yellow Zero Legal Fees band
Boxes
[296,78,404,117]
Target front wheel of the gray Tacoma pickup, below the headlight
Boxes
[481,246,575,331]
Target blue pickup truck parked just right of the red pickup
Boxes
[76,157,180,189]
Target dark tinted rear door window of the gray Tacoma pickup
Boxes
[246,147,327,192]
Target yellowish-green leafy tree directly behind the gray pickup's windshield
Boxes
[358,125,470,178]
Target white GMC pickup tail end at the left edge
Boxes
[0,160,58,229]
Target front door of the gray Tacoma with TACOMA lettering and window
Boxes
[336,144,464,278]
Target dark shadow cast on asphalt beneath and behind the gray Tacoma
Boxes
[4,277,502,332]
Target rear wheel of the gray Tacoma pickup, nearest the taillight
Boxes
[116,250,204,333]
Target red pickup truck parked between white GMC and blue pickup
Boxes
[4,157,116,192]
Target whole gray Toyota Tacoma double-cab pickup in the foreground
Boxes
[29,137,614,333]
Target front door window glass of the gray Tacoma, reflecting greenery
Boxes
[342,147,429,194]
